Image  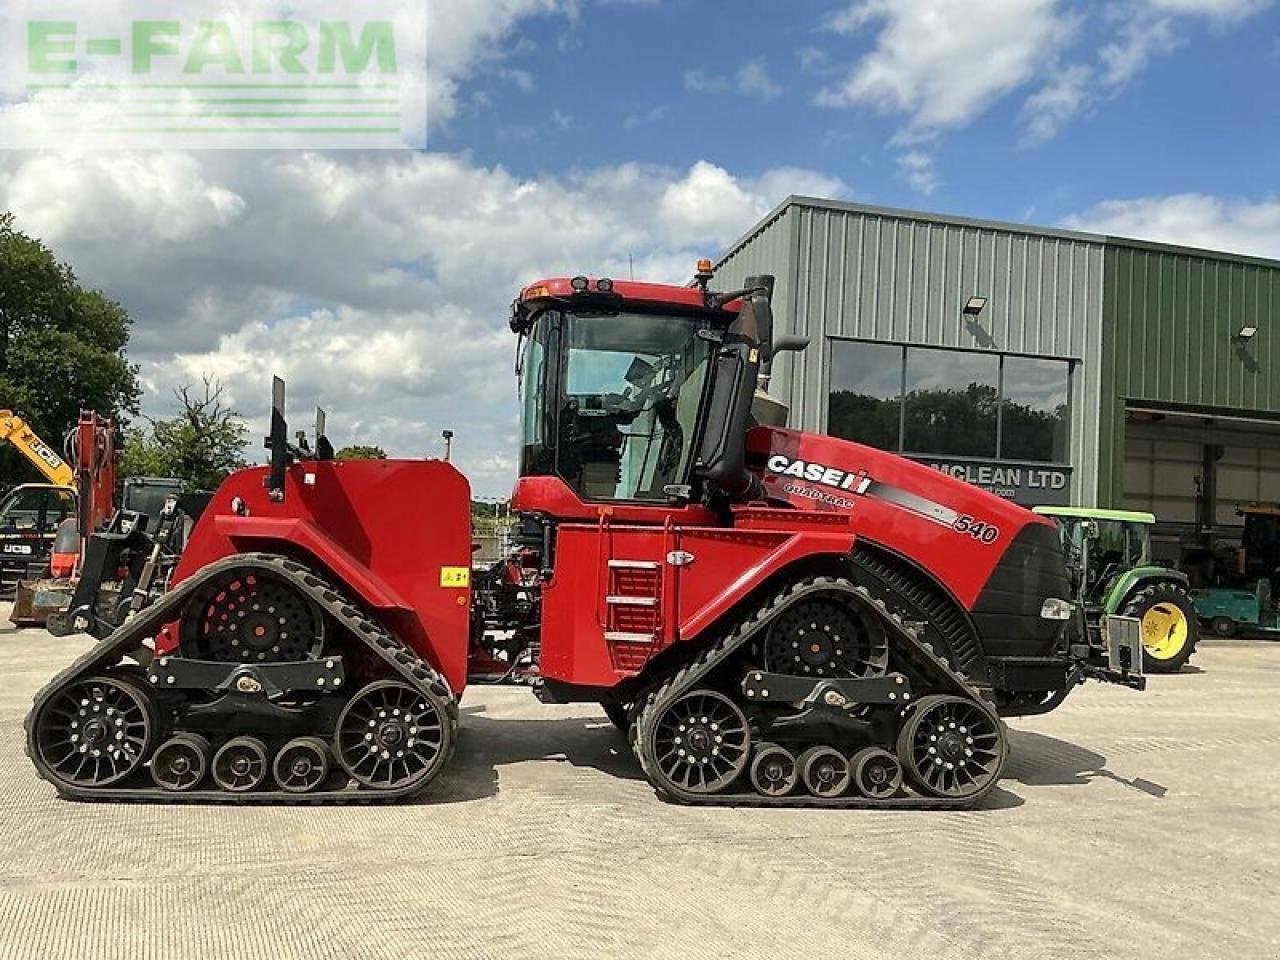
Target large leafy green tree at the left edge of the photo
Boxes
[0,214,141,481]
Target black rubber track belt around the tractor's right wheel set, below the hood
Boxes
[631,576,1004,810]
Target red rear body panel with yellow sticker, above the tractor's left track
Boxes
[167,460,471,692]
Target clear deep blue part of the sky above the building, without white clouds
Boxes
[431,0,1280,223]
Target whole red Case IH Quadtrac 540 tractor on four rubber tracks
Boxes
[27,264,1142,806]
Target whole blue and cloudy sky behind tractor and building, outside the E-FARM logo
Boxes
[0,0,1280,495]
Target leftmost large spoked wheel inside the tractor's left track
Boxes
[35,676,156,788]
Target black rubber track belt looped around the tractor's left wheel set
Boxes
[26,553,458,804]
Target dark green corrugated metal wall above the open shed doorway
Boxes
[1098,241,1280,504]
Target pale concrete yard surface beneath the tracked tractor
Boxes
[0,607,1280,960]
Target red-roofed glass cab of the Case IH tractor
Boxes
[511,262,801,515]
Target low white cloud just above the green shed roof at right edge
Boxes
[1062,193,1280,259]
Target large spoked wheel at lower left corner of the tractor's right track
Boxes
[641,689,751,795]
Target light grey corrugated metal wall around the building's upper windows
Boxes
[718,201,1103,503]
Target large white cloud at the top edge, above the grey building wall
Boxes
[818,0,1074,141]
